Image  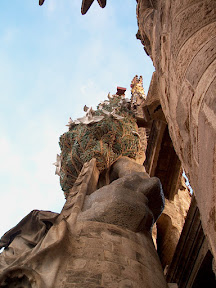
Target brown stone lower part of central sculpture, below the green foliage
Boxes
[0,158,167,288]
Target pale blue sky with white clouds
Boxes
[0,0,154,236]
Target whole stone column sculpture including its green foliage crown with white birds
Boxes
[0,81,167,288]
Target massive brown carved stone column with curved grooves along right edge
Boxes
[137,0,216,257]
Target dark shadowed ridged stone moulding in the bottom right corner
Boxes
[166,197,216,288]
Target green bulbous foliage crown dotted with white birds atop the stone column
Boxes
[56,90,143,198]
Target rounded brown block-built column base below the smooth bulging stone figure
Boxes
[61,222,167,288]
